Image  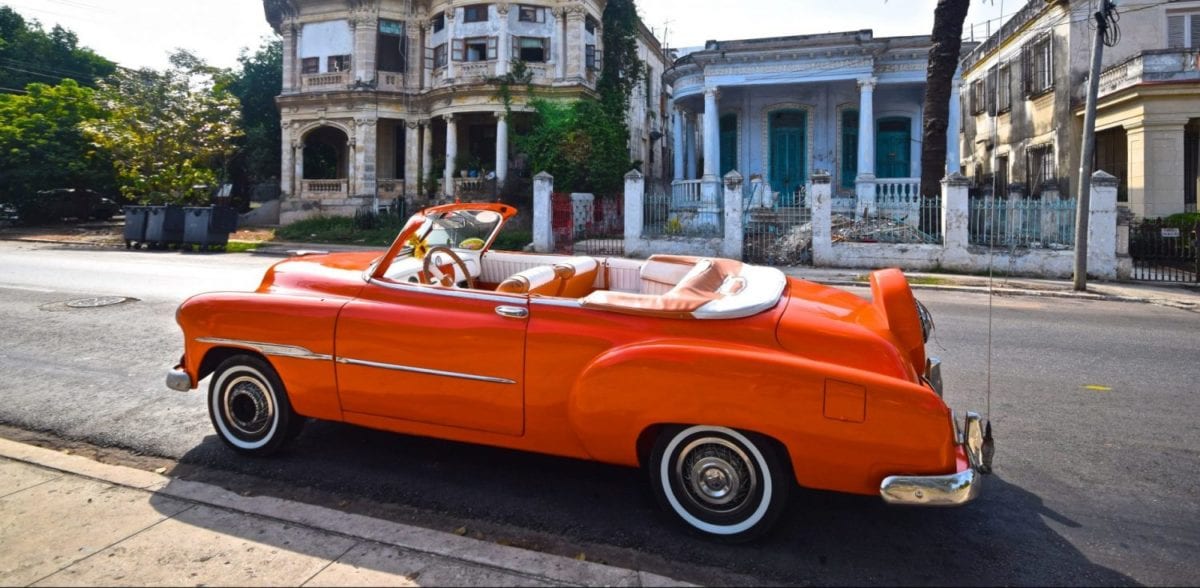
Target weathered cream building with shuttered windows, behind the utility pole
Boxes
[961,0,1200,217]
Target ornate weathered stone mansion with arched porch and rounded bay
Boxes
[263,0,666,223]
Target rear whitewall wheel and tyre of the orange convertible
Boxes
[649,426,792,542]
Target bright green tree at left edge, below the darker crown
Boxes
[0,79,114,216]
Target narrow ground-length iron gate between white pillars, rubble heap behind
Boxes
[742,184,812,265]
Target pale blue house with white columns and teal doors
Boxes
[665,30,959,204]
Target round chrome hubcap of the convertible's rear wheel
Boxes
[674,437,758,512]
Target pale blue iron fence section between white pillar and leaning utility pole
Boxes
[967,196,1075,250]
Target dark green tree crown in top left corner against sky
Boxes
[0,6,116,91]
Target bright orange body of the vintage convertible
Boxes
[178,204,971,494]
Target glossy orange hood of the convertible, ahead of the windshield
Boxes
[258,251,384,296]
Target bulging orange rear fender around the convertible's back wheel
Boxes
[568,341,955,494]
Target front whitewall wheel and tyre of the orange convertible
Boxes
[209,355,305,456]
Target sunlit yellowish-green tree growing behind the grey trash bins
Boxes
[84,52,241,204]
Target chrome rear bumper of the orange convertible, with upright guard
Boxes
[880,413,983,506]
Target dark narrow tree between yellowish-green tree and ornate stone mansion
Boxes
[216,38,283,206]
